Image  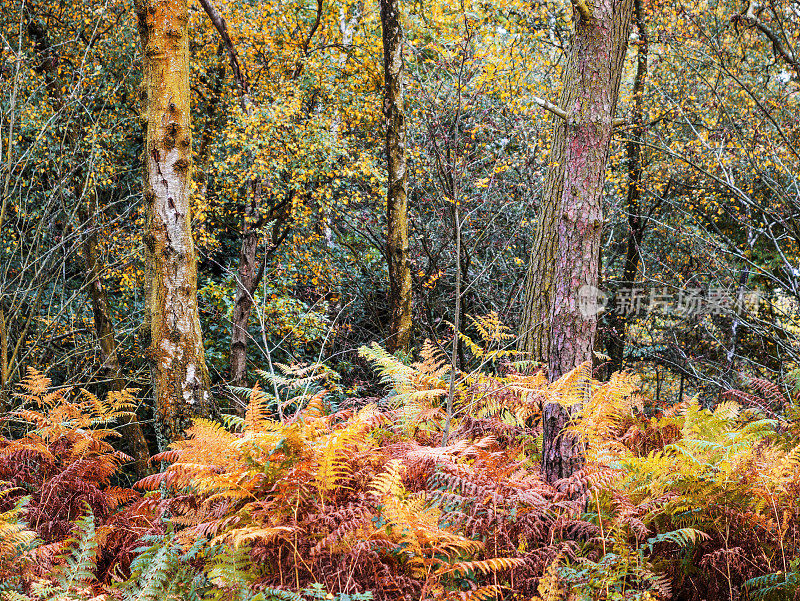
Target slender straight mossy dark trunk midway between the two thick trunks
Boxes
[381,0,412,352]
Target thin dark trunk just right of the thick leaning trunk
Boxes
[607,0,648,374]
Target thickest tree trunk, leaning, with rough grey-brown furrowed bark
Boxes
[520,0,633,482]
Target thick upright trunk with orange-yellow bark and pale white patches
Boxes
[136,0,211,445]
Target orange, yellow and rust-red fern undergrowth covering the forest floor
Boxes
[0,319,800,601]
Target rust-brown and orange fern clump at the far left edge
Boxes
[0,370,149,578]
